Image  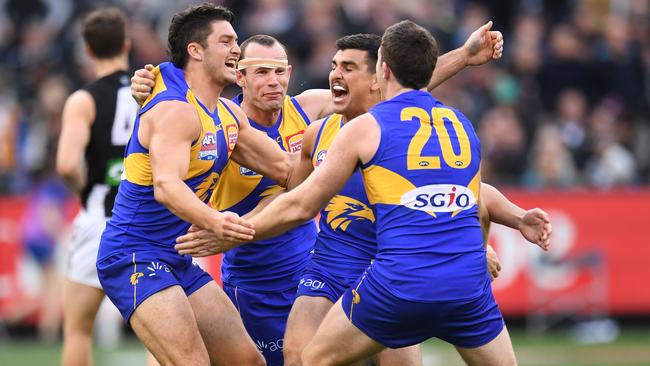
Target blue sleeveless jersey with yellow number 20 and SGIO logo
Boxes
[362,91,489,302]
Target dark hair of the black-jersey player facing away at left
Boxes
[82,7,126,58]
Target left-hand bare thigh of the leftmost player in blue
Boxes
[130,286,211,366]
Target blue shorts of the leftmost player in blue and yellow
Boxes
[97,250,212,322]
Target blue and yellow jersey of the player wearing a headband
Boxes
[211,95,316,291]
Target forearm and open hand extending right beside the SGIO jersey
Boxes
[481,183,553,250]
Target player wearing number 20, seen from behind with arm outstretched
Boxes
[216,22,548,365]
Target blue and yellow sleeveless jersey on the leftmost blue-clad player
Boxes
[98,62,239,259]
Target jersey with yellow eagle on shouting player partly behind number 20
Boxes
[311,114,377,279]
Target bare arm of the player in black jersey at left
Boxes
[56,90,96,191]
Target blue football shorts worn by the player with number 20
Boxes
[342,271,504,348]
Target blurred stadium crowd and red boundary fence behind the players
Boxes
[0,0,650,365]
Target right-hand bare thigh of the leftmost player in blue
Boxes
[189,281,265,366]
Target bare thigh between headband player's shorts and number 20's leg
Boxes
[284,296,333,366]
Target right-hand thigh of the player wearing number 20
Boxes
[456,327,517,366]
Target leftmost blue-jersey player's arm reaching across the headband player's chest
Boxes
[221,98,293,187]
